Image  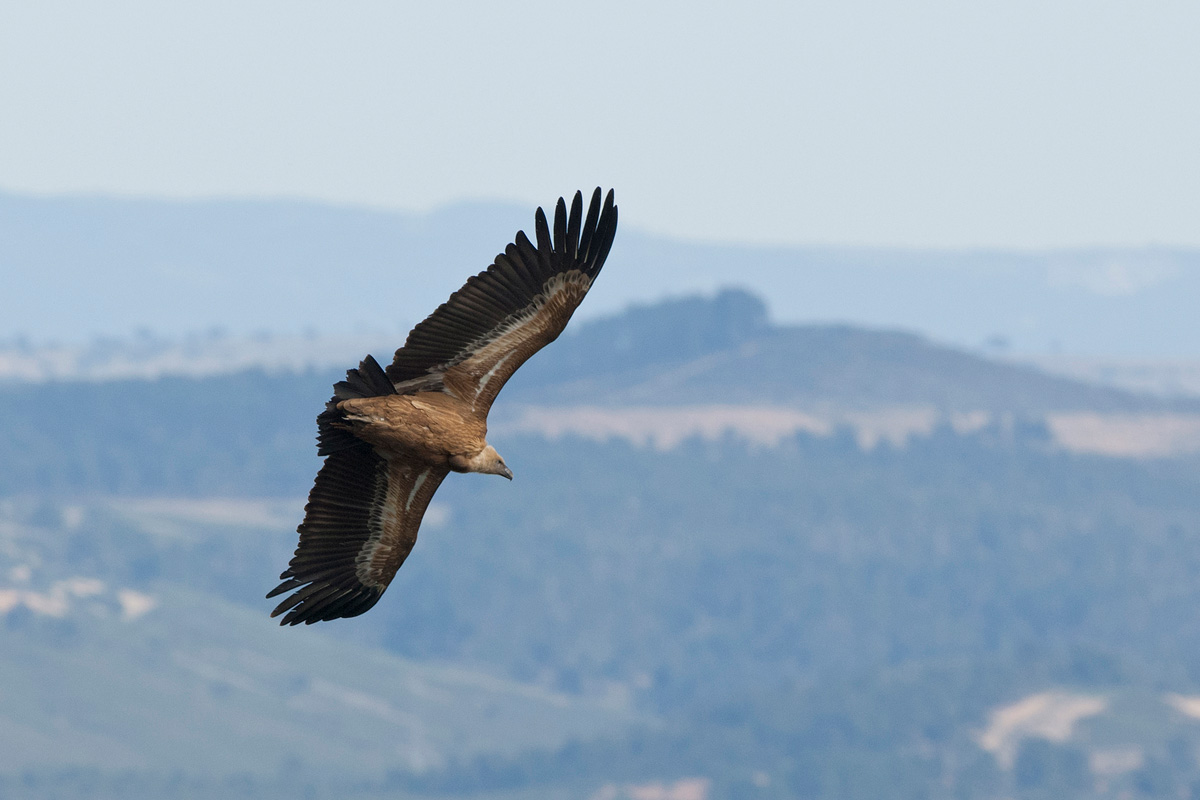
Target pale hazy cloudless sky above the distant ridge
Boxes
[0,0,1200,247]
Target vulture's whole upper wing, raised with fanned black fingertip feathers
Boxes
[388,188,617,414]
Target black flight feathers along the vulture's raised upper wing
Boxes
[388,188,617,392]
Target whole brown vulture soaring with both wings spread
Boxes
[266,188,617,625]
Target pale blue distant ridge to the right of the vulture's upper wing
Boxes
[613,234,1200,357]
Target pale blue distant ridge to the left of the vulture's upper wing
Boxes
[0,194,532,339]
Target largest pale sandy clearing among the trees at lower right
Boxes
[976,692,1109,769]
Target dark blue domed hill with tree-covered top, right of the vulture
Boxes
[505,290,1200,416]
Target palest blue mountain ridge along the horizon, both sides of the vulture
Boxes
[7,187,1200,357]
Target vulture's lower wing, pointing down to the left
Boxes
[266,443,449,625]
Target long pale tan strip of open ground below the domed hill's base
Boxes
[493,405,1200,458]
